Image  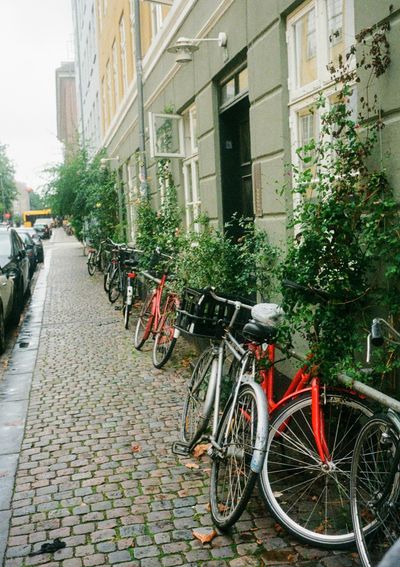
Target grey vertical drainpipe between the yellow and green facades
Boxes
[134,0,149,199]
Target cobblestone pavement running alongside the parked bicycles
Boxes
[1,229,357,567]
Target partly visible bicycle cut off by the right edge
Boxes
[339,319,400,567]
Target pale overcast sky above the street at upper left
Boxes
[0,0,73,193]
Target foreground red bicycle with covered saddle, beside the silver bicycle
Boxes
[247,282,372,549]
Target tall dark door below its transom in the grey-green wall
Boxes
[220,96,254,237]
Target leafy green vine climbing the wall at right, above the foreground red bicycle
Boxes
[281,20,400,388]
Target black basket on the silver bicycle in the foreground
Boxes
[175,288,253,339]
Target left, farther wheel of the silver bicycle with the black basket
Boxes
[182,347,215,447]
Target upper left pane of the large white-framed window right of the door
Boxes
[293,8,317,87]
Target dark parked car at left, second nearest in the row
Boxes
[0,228,30,324]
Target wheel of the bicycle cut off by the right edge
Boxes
[350,415,400,567]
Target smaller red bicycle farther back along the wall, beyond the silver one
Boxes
[134,253,179,368]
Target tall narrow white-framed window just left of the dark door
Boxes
[182,105,201,232]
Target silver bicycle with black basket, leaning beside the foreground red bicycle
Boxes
[173,289,268,530]
